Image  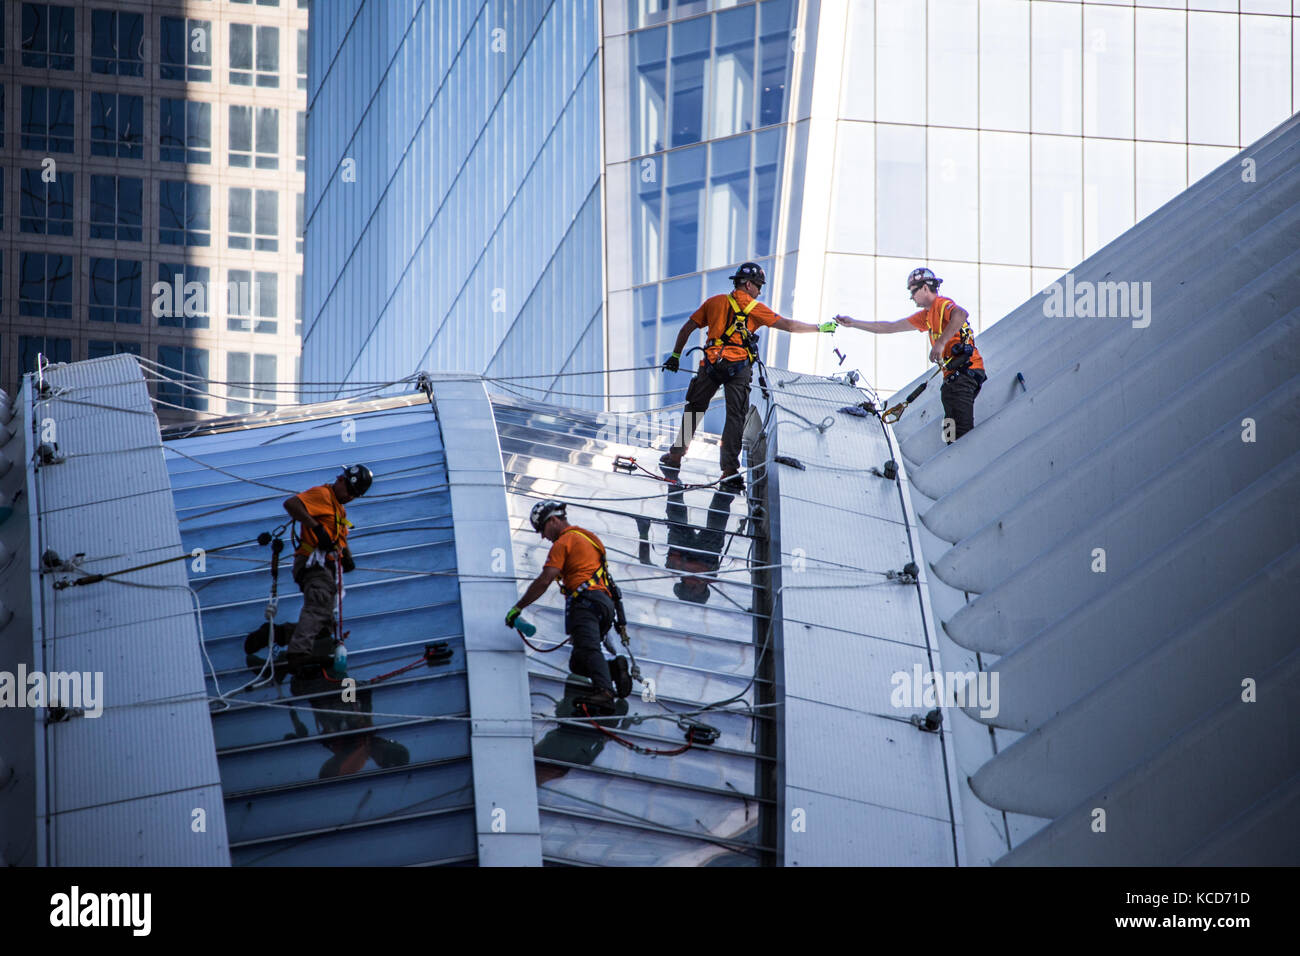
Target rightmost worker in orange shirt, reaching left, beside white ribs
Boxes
[835,268,988,441]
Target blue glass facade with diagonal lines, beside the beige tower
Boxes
[303,0,605,403]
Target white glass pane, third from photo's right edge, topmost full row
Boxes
[1135,9,1187,142]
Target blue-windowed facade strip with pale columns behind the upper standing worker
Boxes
[607,0,797,408]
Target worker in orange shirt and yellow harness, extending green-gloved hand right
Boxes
[659,263,835,492]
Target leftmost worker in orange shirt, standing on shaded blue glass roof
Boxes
[285,464,374,669]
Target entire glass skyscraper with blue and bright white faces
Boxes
[304,0,1300,406]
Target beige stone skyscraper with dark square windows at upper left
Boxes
[0,0,307,416]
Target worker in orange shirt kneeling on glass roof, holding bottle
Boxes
[506,501,632,715]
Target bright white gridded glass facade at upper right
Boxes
[806,0,1300,392]
